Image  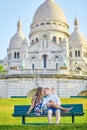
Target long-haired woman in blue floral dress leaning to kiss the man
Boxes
[27,87,44,116]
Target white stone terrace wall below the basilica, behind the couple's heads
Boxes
[0,74,87,98]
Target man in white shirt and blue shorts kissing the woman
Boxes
[43,88,72,124]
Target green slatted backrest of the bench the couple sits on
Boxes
[14,104,83,115]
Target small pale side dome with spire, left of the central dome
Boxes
[9,20,28,48]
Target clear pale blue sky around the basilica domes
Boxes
[0,0,87,60]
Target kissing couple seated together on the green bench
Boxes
[27,87,72,124]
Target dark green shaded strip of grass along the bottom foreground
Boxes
[0,124,87,130]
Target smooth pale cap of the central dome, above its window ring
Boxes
[33,0,67,23]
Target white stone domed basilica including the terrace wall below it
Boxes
[0,0,87,98]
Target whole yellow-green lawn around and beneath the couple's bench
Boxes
[0,98,87,130]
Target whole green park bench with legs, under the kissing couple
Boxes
[12,104,84,124]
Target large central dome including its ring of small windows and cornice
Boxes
[29,0,69,45]
